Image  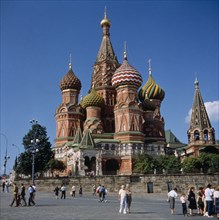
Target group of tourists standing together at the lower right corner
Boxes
[168,184,219,219]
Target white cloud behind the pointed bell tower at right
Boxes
[185,100,219,123]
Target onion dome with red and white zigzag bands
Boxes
[112,49,142,88]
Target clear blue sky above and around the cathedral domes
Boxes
[0,0,219,175]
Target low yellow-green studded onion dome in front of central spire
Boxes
[81,88,104,108]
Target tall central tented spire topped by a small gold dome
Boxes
[91,9,119,132]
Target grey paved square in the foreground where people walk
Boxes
[0,192,216,220]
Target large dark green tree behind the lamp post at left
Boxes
[16,124,52,178]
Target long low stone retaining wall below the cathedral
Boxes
[16,174,219,193]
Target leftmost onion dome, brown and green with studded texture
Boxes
[60,57,81,91]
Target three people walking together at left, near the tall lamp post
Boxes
[10,182,36,207]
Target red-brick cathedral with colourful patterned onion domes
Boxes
[53,12,215,176]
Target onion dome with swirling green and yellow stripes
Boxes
[138,59,165,103]
